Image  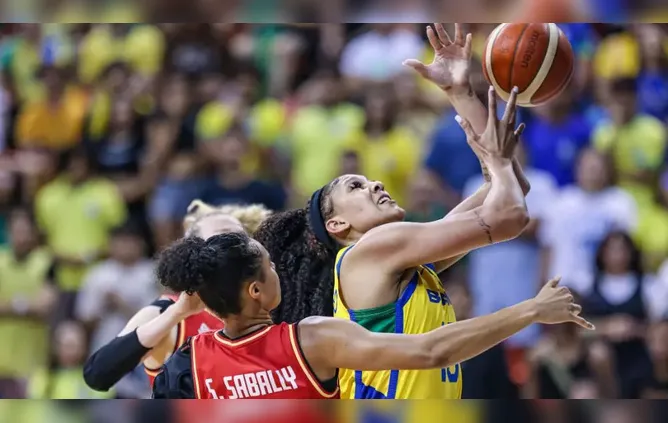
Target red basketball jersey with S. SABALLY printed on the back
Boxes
[190,323,339,399]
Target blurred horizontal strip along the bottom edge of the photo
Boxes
[0,400,668,423]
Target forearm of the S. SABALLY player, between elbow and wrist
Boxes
[423,300,536,367]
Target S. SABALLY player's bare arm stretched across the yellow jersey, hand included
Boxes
[299,278,593,372]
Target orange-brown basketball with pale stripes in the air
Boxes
[482,23,575,107]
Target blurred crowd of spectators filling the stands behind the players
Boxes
[0,24,668,398]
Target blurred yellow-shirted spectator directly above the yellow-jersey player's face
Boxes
[349,88,422,204]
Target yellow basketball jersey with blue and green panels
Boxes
[334,246,462,399]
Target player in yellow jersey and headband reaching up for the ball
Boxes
[255,25,552,399]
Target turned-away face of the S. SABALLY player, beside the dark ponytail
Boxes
[242,240,281,313]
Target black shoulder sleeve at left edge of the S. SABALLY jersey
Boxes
[152,338,196,399]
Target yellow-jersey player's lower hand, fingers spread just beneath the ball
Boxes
[455,87,524,164]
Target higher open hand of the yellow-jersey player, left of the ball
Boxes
[403,23,472,92]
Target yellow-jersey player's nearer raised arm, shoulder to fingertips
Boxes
[346,88,529,272]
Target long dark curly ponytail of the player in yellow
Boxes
[255,179,338,323]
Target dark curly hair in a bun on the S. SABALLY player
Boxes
[156,232,264,317]
